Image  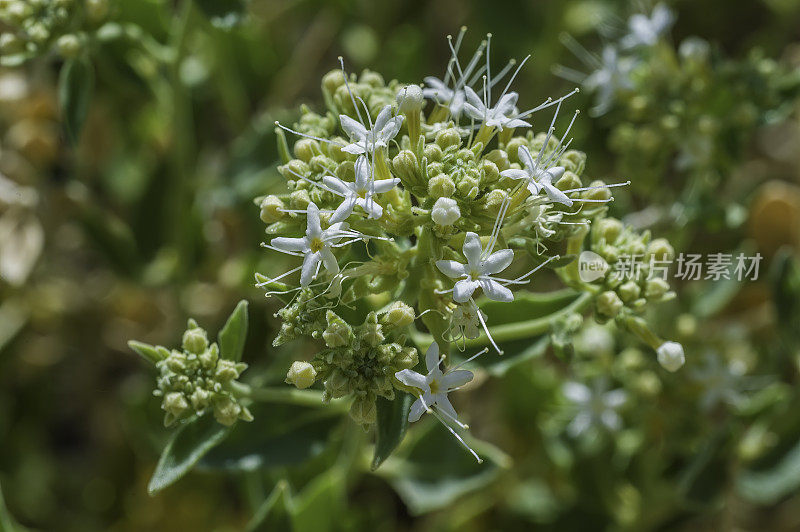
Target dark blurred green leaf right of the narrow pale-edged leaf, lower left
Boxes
[199,404,343,471]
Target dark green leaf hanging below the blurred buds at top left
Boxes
[58,57,94,144]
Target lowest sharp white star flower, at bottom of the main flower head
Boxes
[395,342,473,423]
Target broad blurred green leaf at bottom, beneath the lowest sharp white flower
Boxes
[378,420,511,515]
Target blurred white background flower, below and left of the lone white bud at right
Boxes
[562,381,628,437]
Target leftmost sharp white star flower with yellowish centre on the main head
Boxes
[270,202,353,286]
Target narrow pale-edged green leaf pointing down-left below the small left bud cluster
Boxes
[147,416,231,495]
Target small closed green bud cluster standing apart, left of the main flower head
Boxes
[153,320,253,426]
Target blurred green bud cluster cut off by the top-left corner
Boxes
[0,0,110,65]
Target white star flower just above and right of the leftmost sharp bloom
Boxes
[322,155,400,222]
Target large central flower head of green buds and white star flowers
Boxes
[257,31,680,460]
